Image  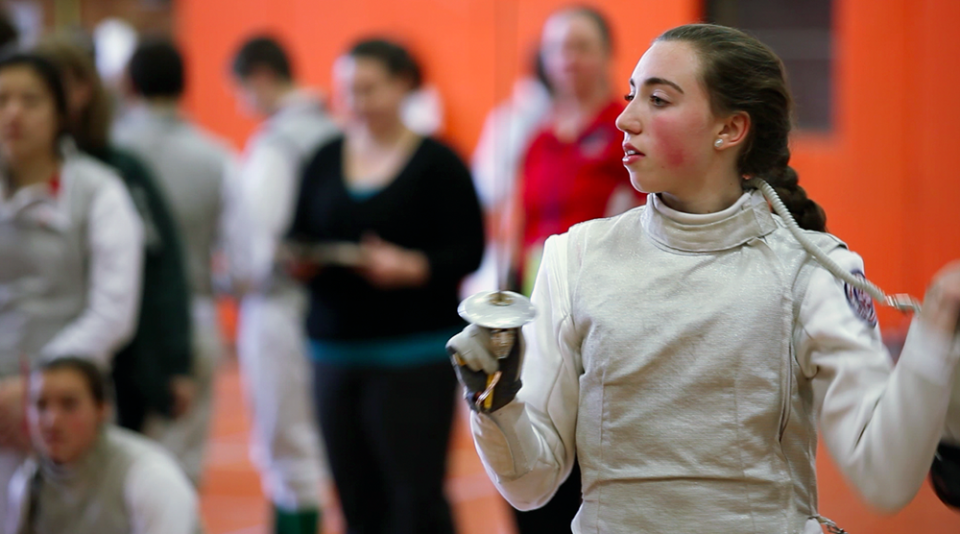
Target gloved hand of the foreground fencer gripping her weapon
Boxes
[447,324,525,413]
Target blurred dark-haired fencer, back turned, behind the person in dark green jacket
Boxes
[113,41,239,484]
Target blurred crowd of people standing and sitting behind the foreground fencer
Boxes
[0,7,644,534]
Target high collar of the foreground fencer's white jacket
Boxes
[642,192,777,252]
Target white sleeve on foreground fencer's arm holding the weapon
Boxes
[471,235,582,510]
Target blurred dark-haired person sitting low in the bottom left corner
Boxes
[3,357,199,534]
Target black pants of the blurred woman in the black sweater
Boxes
[314,361,456,534]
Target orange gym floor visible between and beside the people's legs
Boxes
[201,361,960,534]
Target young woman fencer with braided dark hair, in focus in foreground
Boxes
[449,24,960,534]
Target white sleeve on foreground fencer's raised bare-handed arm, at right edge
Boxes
[797,249,960,512]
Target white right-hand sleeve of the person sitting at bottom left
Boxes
[124,454,199,534]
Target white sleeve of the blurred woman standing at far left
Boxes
[42,179,144,367]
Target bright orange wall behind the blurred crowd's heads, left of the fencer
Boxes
[177,0,697,154]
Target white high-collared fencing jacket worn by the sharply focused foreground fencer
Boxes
[472,192,960,534]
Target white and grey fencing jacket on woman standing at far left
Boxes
[0,147,143,377]
